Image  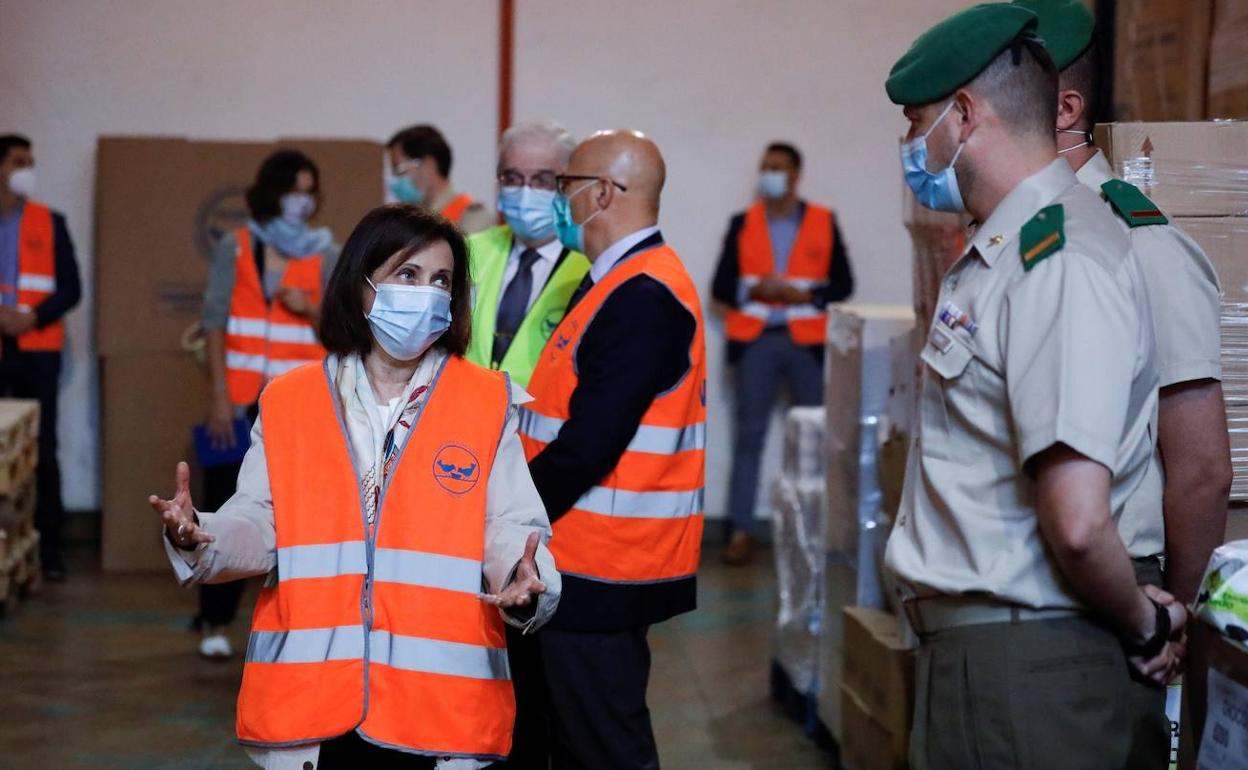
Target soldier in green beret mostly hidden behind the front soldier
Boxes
[1016,0,1232,604]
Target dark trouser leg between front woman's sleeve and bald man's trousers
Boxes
[499,625,550,770]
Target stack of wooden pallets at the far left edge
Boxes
[0,399,41,615]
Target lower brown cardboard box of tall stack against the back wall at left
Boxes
[100,353,208,572]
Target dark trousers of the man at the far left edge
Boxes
[0,339,65,569]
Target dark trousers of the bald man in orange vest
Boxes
[537,626,659,770]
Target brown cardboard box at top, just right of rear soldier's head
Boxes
[1113,0,1213,120]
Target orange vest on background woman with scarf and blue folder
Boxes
[226,227,324,406]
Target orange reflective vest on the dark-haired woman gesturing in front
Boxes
[237,356,515,759]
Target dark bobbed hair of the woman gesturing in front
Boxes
[319,203,472,356]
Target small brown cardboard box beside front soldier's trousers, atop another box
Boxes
[841,607,915,756]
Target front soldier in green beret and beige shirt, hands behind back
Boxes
[885,4,1187,770]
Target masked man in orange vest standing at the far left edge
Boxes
[0,134,82,580]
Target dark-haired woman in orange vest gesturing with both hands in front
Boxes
[149,205,560,770]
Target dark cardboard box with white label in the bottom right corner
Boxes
[1178,621,1248,770]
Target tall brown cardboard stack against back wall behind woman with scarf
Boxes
[95,137,382,570]
